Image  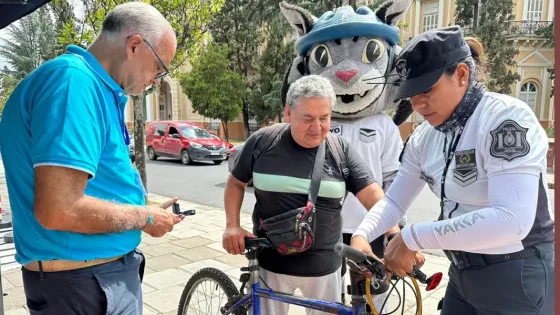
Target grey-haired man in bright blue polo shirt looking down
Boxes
[0,2,183,314]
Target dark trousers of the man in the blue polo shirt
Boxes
[22,250,145,315]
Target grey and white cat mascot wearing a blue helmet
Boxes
[280,0,412,312]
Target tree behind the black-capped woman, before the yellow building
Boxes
[455,0,521,94]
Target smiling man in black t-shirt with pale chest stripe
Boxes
[223,75,399,315]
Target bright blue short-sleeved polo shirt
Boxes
[0,46,145,264]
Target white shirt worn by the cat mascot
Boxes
[330,113,403,233]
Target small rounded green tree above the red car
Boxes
[181,44,245,140]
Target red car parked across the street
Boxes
[146,121,231,164]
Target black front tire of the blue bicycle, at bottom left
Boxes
[177,267,247,315]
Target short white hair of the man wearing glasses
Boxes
[101,2,175,45]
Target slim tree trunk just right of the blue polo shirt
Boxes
[132,93,148,191]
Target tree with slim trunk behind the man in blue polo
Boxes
[53,0,224,187]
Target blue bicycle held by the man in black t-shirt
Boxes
[177,238,441,315]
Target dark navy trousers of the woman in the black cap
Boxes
[442,251,554,315]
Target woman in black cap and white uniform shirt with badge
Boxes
[351,26,554,315]
